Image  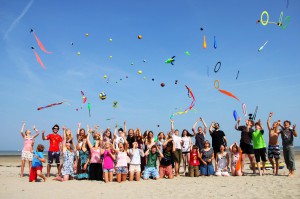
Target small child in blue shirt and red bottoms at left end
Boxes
[29,144,46,182]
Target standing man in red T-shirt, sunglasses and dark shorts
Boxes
[42,124,62,178]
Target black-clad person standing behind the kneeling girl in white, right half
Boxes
[209,122,227,162]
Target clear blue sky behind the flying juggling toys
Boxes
[0,0,300,150]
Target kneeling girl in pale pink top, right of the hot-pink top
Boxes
[115,142,128,183]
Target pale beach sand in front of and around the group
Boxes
[0,152,300,199]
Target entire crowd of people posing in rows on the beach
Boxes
[20,113,297,182]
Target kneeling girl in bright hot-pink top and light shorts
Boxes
[101,142,116,182]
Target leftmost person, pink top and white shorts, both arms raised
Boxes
[20,122,40,177]
